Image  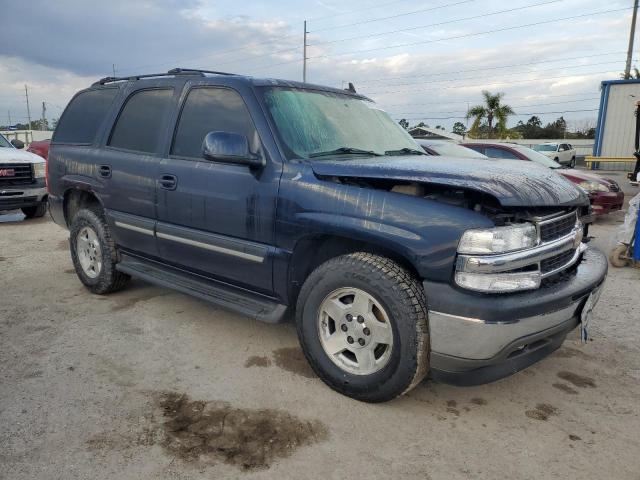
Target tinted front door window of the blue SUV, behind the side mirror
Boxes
[171,87,257,158]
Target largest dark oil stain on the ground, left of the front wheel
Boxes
[159,393,328,470]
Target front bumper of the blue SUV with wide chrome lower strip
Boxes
[424,247,608,385]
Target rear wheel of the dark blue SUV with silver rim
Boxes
[69,209,130,295]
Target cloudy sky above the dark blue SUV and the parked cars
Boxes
[0,0,638,128]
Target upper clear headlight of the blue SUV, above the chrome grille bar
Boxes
[458,223,538,254]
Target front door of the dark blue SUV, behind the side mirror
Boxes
[156,86,281,294]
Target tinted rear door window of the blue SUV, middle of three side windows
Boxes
[108,89,173,153]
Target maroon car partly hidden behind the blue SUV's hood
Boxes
[462,143,624,215]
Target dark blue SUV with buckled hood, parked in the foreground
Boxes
[48,69,607,402]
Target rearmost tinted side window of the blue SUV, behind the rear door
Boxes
[53,88,118,143]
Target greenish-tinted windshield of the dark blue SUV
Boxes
[264,87,423,158]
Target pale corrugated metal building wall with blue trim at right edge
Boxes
[600,83,640,157]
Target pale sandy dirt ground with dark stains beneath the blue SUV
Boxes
[0,203,640,480]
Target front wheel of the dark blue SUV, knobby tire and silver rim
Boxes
[296,252,429,402]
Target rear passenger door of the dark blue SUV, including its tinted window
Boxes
[97,85,177,256]
